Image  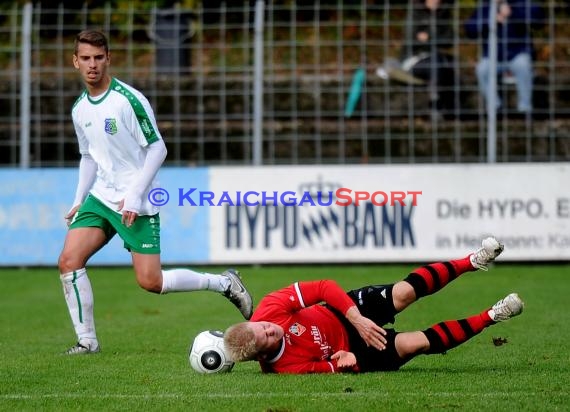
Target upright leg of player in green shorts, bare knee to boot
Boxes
[58,227,107,355]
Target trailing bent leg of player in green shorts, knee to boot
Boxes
[132,252,253,319]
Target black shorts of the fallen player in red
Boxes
[328,285,407,372]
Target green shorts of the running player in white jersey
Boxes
[69,194,160,255]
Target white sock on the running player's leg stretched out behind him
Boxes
[160,269,230,294]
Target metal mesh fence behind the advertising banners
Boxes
[0,0,570,167]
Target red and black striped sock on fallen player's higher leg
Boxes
[404,256,475,299]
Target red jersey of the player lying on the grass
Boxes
[251,280,354,373]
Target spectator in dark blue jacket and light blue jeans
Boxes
[465,0,544,114]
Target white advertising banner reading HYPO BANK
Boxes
[206,163,570,263]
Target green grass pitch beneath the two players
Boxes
[0,262,570,412]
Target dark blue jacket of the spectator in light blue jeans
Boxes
[465,0,544,61]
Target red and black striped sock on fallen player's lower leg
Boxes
[423,309,495,354]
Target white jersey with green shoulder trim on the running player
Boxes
[71,78,162,215]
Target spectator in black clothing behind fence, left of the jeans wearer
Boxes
[400,0,456,113]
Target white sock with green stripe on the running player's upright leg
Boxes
[61,268,97,345]
